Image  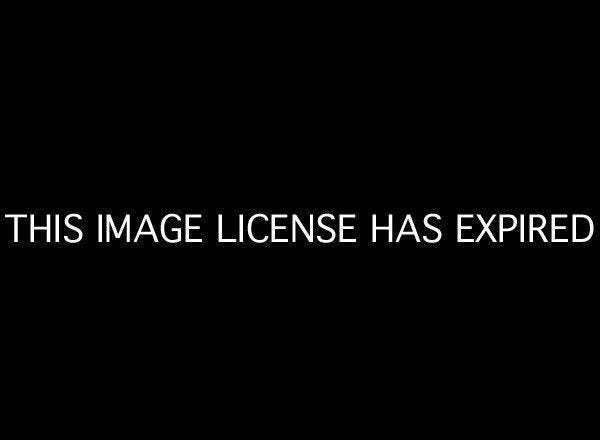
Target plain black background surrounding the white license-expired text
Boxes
[1,5,598,433]
